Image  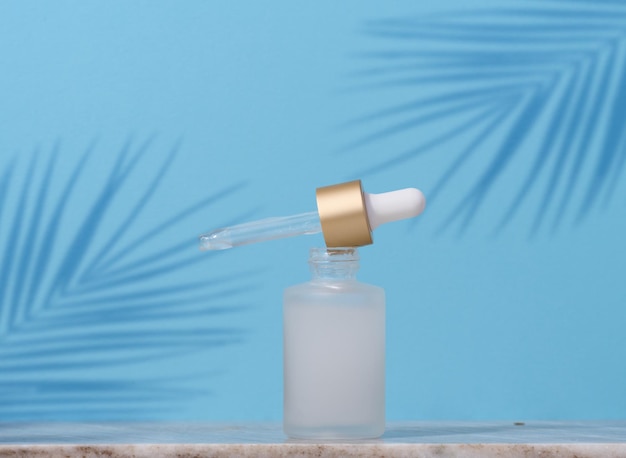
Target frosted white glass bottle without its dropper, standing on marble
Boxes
[283,248,385,439]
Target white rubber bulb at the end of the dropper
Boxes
[364,188,426,231]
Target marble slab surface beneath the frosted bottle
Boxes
[0,421,626,458]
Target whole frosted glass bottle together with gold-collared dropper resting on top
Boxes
[200,180,426,439]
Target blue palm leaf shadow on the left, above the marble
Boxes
[0,139,255,420]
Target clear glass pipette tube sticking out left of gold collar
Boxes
[200,212,322,251]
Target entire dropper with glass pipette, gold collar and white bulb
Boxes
[200,180,426,250]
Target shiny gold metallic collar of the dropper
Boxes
[315,180,373,247]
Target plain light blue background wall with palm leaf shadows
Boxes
[0,0,626,420]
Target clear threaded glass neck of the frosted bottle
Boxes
[309,247,359,281]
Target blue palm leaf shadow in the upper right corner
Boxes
[343,0,626,233]
